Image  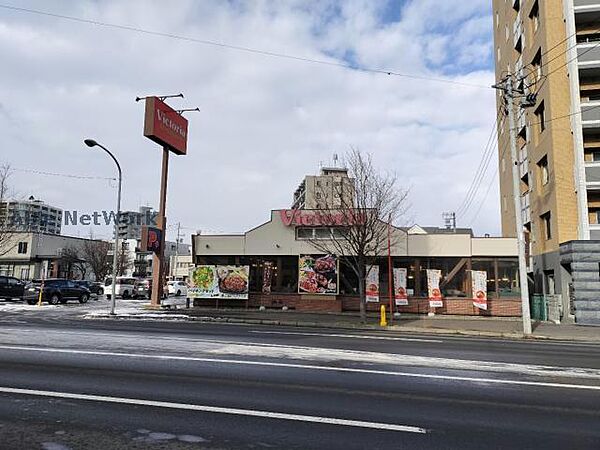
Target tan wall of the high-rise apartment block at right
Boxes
[493,0,578,255]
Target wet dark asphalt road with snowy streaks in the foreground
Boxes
[0,304,600,450]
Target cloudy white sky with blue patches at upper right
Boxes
[0,0,499,243]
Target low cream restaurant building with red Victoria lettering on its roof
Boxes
[192,169,521,317]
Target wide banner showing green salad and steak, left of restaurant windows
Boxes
[188,266,250,300]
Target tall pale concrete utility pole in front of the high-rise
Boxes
[492,74,531,336]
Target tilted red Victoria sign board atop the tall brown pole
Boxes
[144,97,188,155]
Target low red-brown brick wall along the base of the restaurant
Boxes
[194,294,521,317]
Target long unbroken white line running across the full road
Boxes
[0,345,600,391]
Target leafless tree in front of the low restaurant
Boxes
[310,148,408,321]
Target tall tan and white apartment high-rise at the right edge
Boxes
[493,0,600,324]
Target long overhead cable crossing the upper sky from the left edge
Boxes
[0,4,489,89]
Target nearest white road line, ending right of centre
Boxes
[0,387,427,434]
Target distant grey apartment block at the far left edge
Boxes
[0,196,63,234]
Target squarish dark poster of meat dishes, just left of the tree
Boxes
[298,255,339,295]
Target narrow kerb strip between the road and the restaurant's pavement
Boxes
[77,314,600,344]
